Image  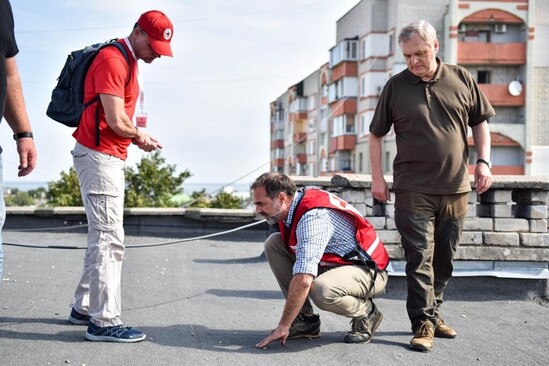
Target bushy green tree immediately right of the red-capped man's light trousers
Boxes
[125,151,191,207]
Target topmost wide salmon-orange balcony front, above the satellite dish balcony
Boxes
[458,42,526,65]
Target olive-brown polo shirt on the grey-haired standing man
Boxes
[370,58,495,194]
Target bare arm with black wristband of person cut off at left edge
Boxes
[4,57,37,177]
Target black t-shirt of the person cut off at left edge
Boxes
[0,0,19,121]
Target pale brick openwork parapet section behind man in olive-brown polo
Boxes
[292,174,549,262]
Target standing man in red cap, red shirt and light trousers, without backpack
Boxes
[69,10,173,343]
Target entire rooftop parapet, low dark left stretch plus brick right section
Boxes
[4,174,549,267]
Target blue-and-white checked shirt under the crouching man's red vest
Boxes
[284,191,357,276]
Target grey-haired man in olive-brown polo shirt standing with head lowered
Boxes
[369,20,495,351]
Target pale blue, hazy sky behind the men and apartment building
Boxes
[0,0,358,184]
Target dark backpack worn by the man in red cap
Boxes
[46,39,130,146]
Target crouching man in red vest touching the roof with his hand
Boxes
[251,173,389,348]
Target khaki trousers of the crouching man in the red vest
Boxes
[265,233,388,318]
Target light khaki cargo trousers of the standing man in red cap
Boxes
[72,143,125,327]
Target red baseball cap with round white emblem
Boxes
[137,10,173,56]
